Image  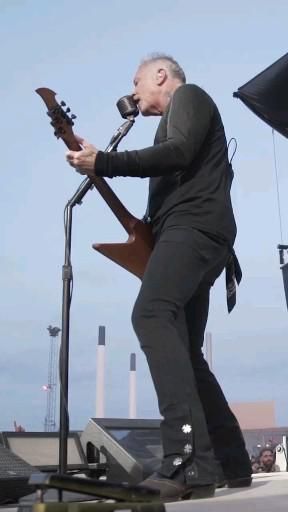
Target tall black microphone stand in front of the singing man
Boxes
[59,115,135,473]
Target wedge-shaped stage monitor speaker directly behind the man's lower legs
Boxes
[80,418,163,484]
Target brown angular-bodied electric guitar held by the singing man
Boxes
[36,87,154,279]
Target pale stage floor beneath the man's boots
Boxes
[0,472,288,512]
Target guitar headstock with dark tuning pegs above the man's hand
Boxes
[36,87,81,151]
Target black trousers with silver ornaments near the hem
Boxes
[132,226,250,484]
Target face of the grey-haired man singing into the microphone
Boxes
[133,63,161,116]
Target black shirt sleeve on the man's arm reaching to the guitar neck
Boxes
[95,84,214,178]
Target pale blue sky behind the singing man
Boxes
[0,0,288,430]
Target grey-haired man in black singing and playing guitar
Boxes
[66,54,251,501]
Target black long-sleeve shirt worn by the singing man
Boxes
[95,84,236,246]
